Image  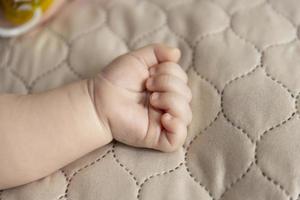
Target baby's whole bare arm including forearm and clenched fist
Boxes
[0,44,192,189]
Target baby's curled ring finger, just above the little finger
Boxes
[150,92,192,125]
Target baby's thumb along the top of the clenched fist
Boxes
[129,44,181,67]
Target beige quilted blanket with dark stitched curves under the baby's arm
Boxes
[0,0,300,200]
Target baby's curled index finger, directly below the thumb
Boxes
[149,62,188,83]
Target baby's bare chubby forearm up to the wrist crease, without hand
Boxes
[0,80,112,189]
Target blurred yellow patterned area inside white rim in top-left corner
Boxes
[0,0,53,25]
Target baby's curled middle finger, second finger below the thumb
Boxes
[146,74,192,102]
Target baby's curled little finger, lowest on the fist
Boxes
[160,113,187,152]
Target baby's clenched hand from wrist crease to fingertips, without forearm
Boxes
[92,44,192,152]
